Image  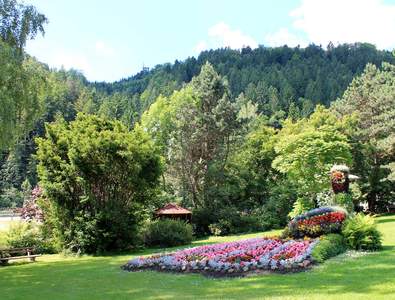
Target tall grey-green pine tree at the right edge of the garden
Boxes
[332,63,395,211]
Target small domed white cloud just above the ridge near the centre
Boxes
[195,22,258,53]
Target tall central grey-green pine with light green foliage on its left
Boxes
[142,63,237,207]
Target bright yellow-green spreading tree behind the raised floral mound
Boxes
[273,106,352,199]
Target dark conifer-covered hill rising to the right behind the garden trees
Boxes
[92,43,395,115]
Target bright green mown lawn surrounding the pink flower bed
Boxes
[0,215,395,300]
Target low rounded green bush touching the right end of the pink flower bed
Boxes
[311,233,347,262]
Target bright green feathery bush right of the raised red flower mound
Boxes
[342,213,381,251]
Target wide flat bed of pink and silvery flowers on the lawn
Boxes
[122,238,318,275]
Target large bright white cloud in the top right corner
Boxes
[290,0,395,49]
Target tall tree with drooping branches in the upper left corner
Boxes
[0,0,47,149]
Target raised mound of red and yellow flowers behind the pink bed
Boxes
[288,207,347,238]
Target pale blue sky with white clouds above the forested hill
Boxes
[24,0,395,82]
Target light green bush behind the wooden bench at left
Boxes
[6,222,57,253]
